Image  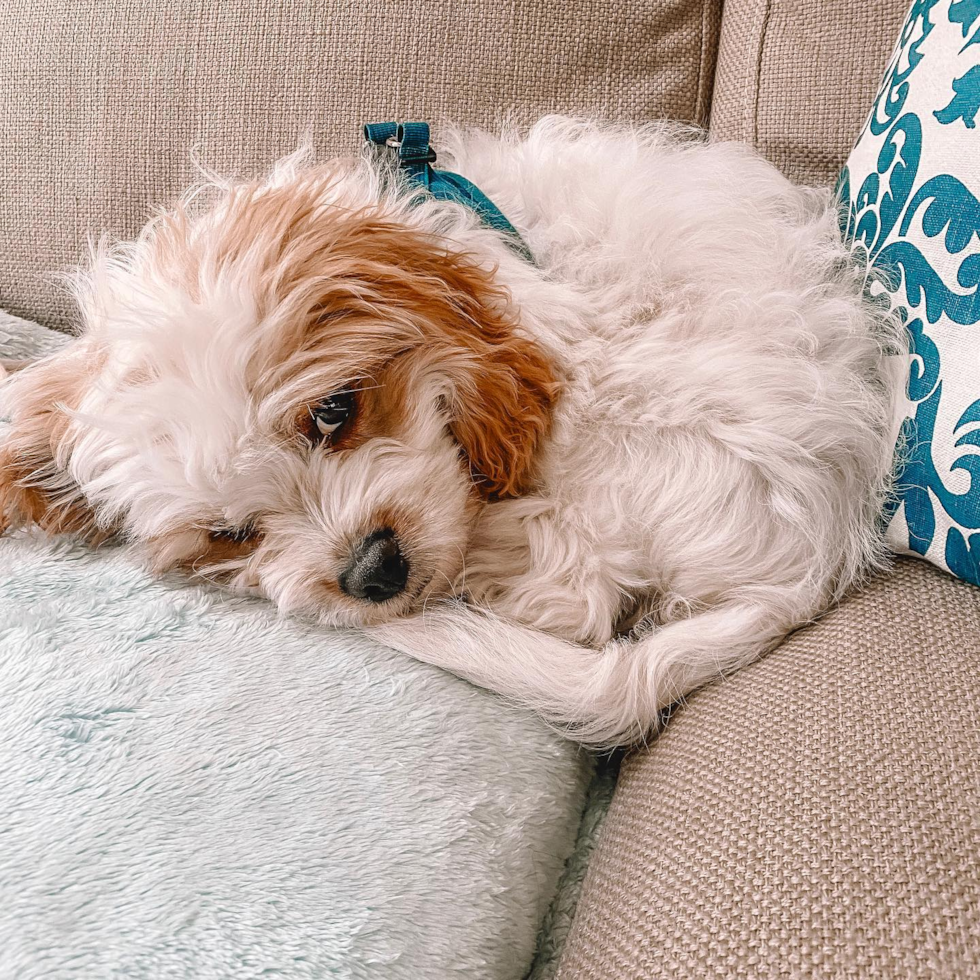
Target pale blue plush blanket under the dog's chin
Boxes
[0,319,592,980]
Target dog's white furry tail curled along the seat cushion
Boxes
[369,599,792,748]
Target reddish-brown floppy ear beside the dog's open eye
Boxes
[322,217,560,498]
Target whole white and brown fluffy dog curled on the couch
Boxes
[0,117,903,746]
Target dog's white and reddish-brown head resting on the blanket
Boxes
[0,158,556,624]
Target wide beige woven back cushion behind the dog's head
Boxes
[0,0,721,329]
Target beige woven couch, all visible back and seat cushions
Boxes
[0,0,980,980]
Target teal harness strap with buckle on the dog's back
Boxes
[364,122,534,264]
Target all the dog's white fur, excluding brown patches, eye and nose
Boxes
[5,118,902,745]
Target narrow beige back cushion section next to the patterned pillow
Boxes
[711,0,909,184]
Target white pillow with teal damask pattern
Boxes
[840,0,980,585]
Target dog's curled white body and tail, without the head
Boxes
[377,119,904,745]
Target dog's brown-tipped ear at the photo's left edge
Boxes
[0,347,104,539]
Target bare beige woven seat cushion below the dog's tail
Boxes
[558,560,980,980]
